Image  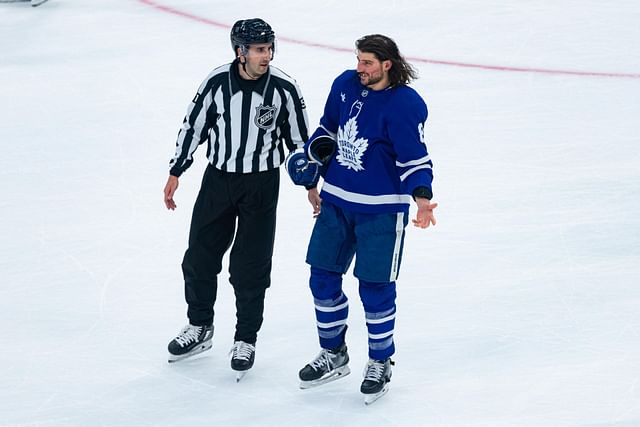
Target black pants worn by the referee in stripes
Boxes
[182,165,280,344]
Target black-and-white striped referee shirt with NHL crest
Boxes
[170,60,309,176]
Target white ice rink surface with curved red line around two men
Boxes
[0,0,640,427]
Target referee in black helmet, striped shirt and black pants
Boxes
[164,18,308,380]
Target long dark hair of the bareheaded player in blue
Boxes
[356,34,418,86]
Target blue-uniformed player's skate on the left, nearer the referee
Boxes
[299,344,351,389]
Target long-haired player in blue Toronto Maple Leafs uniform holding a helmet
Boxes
[287,34,437,404]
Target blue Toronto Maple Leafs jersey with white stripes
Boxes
[307,70,433,213]
